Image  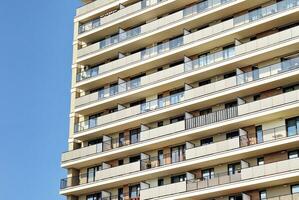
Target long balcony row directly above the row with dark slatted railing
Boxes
[75,54,299,136]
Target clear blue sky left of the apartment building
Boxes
[0,0,80,200]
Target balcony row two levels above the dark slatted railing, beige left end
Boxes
[75,26,299,113]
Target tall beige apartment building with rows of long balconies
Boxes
[60,0,299,200]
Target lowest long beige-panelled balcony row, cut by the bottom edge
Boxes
[140,158,299,200]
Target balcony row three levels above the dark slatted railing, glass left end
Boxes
[77,1,296,73]
